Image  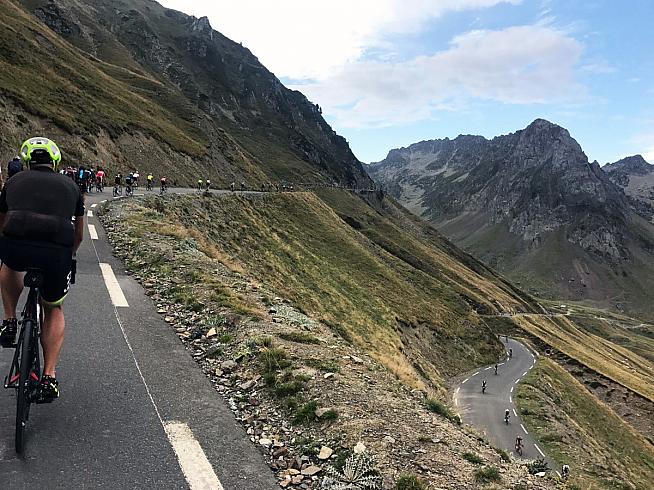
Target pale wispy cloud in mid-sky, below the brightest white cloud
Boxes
[296,25,584,127]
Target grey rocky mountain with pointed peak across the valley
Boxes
[368,120,654,314]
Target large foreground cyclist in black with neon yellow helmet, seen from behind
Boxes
[0,138,84,402]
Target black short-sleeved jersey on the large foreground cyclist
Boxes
[0,166,84,247]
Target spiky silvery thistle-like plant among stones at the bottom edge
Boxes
[321,452,382,490]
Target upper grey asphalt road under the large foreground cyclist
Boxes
[0,188,279,490]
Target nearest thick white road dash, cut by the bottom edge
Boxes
[164,422,225,490]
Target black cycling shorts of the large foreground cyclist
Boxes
[0,237,73,306]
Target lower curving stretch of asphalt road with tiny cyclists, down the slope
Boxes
[454,338,552,468]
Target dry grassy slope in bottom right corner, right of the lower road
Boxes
[516,359,654,490]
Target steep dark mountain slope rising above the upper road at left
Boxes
[0,0,369,185]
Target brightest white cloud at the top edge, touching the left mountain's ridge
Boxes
[159,0,521,79]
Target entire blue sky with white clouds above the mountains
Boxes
[161,0,654,164]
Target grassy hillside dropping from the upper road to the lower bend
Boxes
[111,191,548,390]
